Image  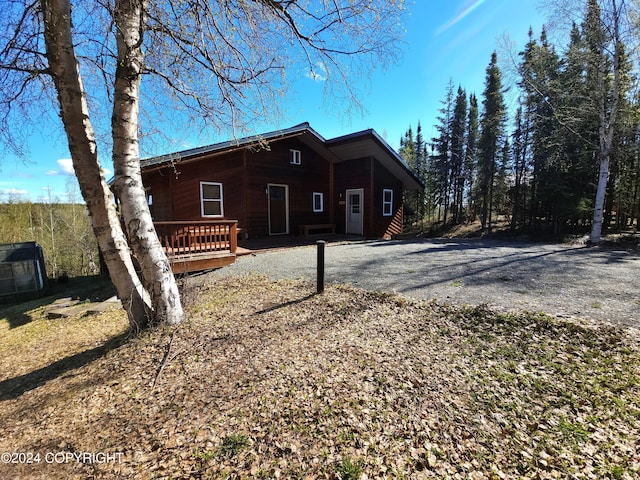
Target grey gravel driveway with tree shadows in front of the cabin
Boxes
[213,239,640,327]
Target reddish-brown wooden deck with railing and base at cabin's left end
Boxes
[154,220,238,273]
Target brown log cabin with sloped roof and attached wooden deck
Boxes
[141,123,424,273]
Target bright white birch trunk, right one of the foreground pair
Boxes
[111,0,184,325]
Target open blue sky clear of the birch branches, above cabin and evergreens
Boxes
[0,0,544,202]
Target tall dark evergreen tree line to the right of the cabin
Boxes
[400,0,640,238]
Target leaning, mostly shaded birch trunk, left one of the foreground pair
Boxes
[41,0,150,328]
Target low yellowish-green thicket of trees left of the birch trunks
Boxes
[0,201,100,278]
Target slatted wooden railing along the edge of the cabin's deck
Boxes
[154,220,238,256]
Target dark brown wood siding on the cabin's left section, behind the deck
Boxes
[144,139,335,238]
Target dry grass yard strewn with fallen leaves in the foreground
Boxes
[0,277,640,479]
